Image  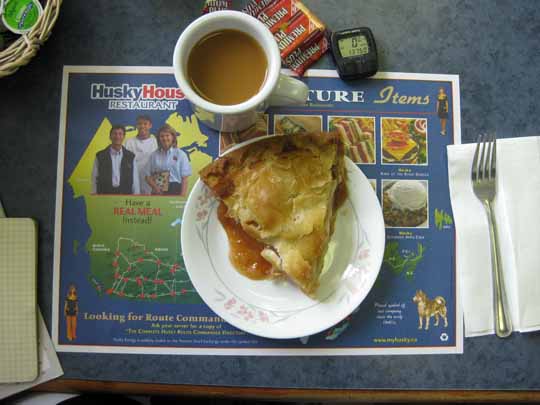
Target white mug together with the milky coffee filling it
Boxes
[173,10,309,132]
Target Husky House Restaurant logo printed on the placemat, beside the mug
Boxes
[90,83,185,110]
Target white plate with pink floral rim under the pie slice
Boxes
[181,137,385,339]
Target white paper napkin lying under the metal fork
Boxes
[448,136,540,337]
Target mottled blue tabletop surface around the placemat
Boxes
[0,0,540,389]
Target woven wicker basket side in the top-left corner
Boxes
[0,0,62,77]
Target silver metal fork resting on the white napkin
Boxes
[471,135,512,338]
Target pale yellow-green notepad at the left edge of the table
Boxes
[0,218,38,383]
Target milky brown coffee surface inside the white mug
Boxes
[187,29,268,105]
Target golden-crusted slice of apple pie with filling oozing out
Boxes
[200,132,346,295]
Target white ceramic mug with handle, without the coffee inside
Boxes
[173,10,308,132]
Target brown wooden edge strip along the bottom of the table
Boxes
[32,378,540,402]
